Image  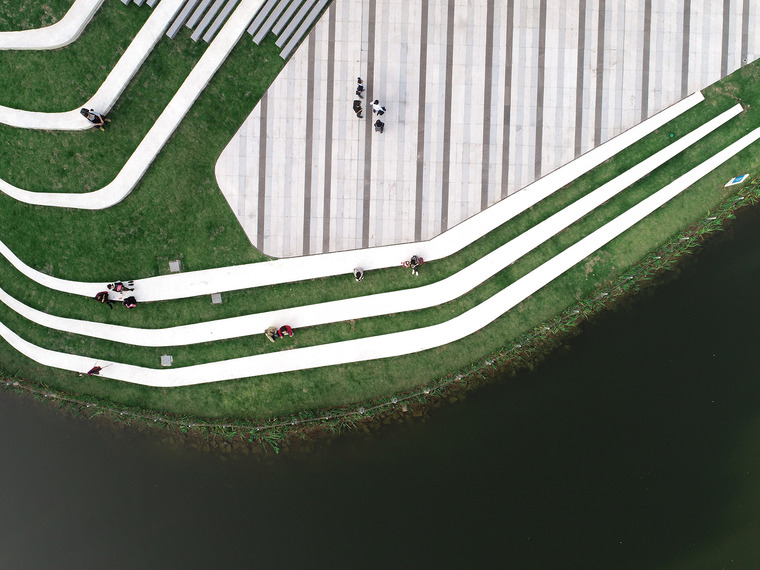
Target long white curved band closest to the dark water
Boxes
[0,125,760,387]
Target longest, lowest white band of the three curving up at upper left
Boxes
[0,0,264,206]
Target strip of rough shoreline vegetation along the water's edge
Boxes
[0,182,760,453]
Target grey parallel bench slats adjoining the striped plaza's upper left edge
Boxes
[248,0,331,59]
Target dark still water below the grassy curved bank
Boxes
[0,208,760,569]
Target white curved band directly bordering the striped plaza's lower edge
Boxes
[0,92,704,302]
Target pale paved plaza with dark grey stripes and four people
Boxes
[216,0,760,257]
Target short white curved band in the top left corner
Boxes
[0,0,103,50]
